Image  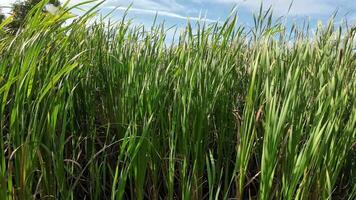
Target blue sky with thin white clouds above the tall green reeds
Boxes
[0,0,356,27]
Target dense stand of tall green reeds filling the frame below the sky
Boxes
[0,2,356,200]
